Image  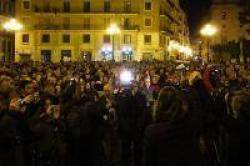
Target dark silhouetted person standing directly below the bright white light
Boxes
[117,83,147,166]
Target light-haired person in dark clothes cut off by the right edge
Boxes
[225,91,250,166]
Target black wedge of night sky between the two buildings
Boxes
[180,0,212,36]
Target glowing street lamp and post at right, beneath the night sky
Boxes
[200,24,218,60]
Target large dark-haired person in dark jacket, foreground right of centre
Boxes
[145,87,203,166]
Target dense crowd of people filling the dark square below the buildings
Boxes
[0,61,250,166]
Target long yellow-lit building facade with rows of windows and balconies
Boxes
[15,0,189,62]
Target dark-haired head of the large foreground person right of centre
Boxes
[156,87,189,123]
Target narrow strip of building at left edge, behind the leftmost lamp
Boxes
[0,0,15,61]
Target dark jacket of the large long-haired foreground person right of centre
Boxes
[145,121,203,166]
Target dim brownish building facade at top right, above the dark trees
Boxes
[211,0,250,44]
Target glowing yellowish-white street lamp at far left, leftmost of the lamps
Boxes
[3,18,23,61]
